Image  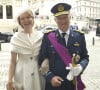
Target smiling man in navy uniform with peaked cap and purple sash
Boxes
[39,3,89,90]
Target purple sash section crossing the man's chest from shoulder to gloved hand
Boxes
[48,32,72,66]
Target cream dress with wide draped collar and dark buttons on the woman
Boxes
[11,31,43,90]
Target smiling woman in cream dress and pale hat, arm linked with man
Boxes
[7,10,43,90]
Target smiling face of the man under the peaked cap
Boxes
[55,14,70,32]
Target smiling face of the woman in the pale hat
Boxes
[19,12,34,29]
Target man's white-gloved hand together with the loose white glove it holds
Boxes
[66,64,83,81]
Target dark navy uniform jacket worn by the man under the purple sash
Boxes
[39,30,89,90]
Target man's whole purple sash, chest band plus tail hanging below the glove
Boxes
[48,32,85,90]
